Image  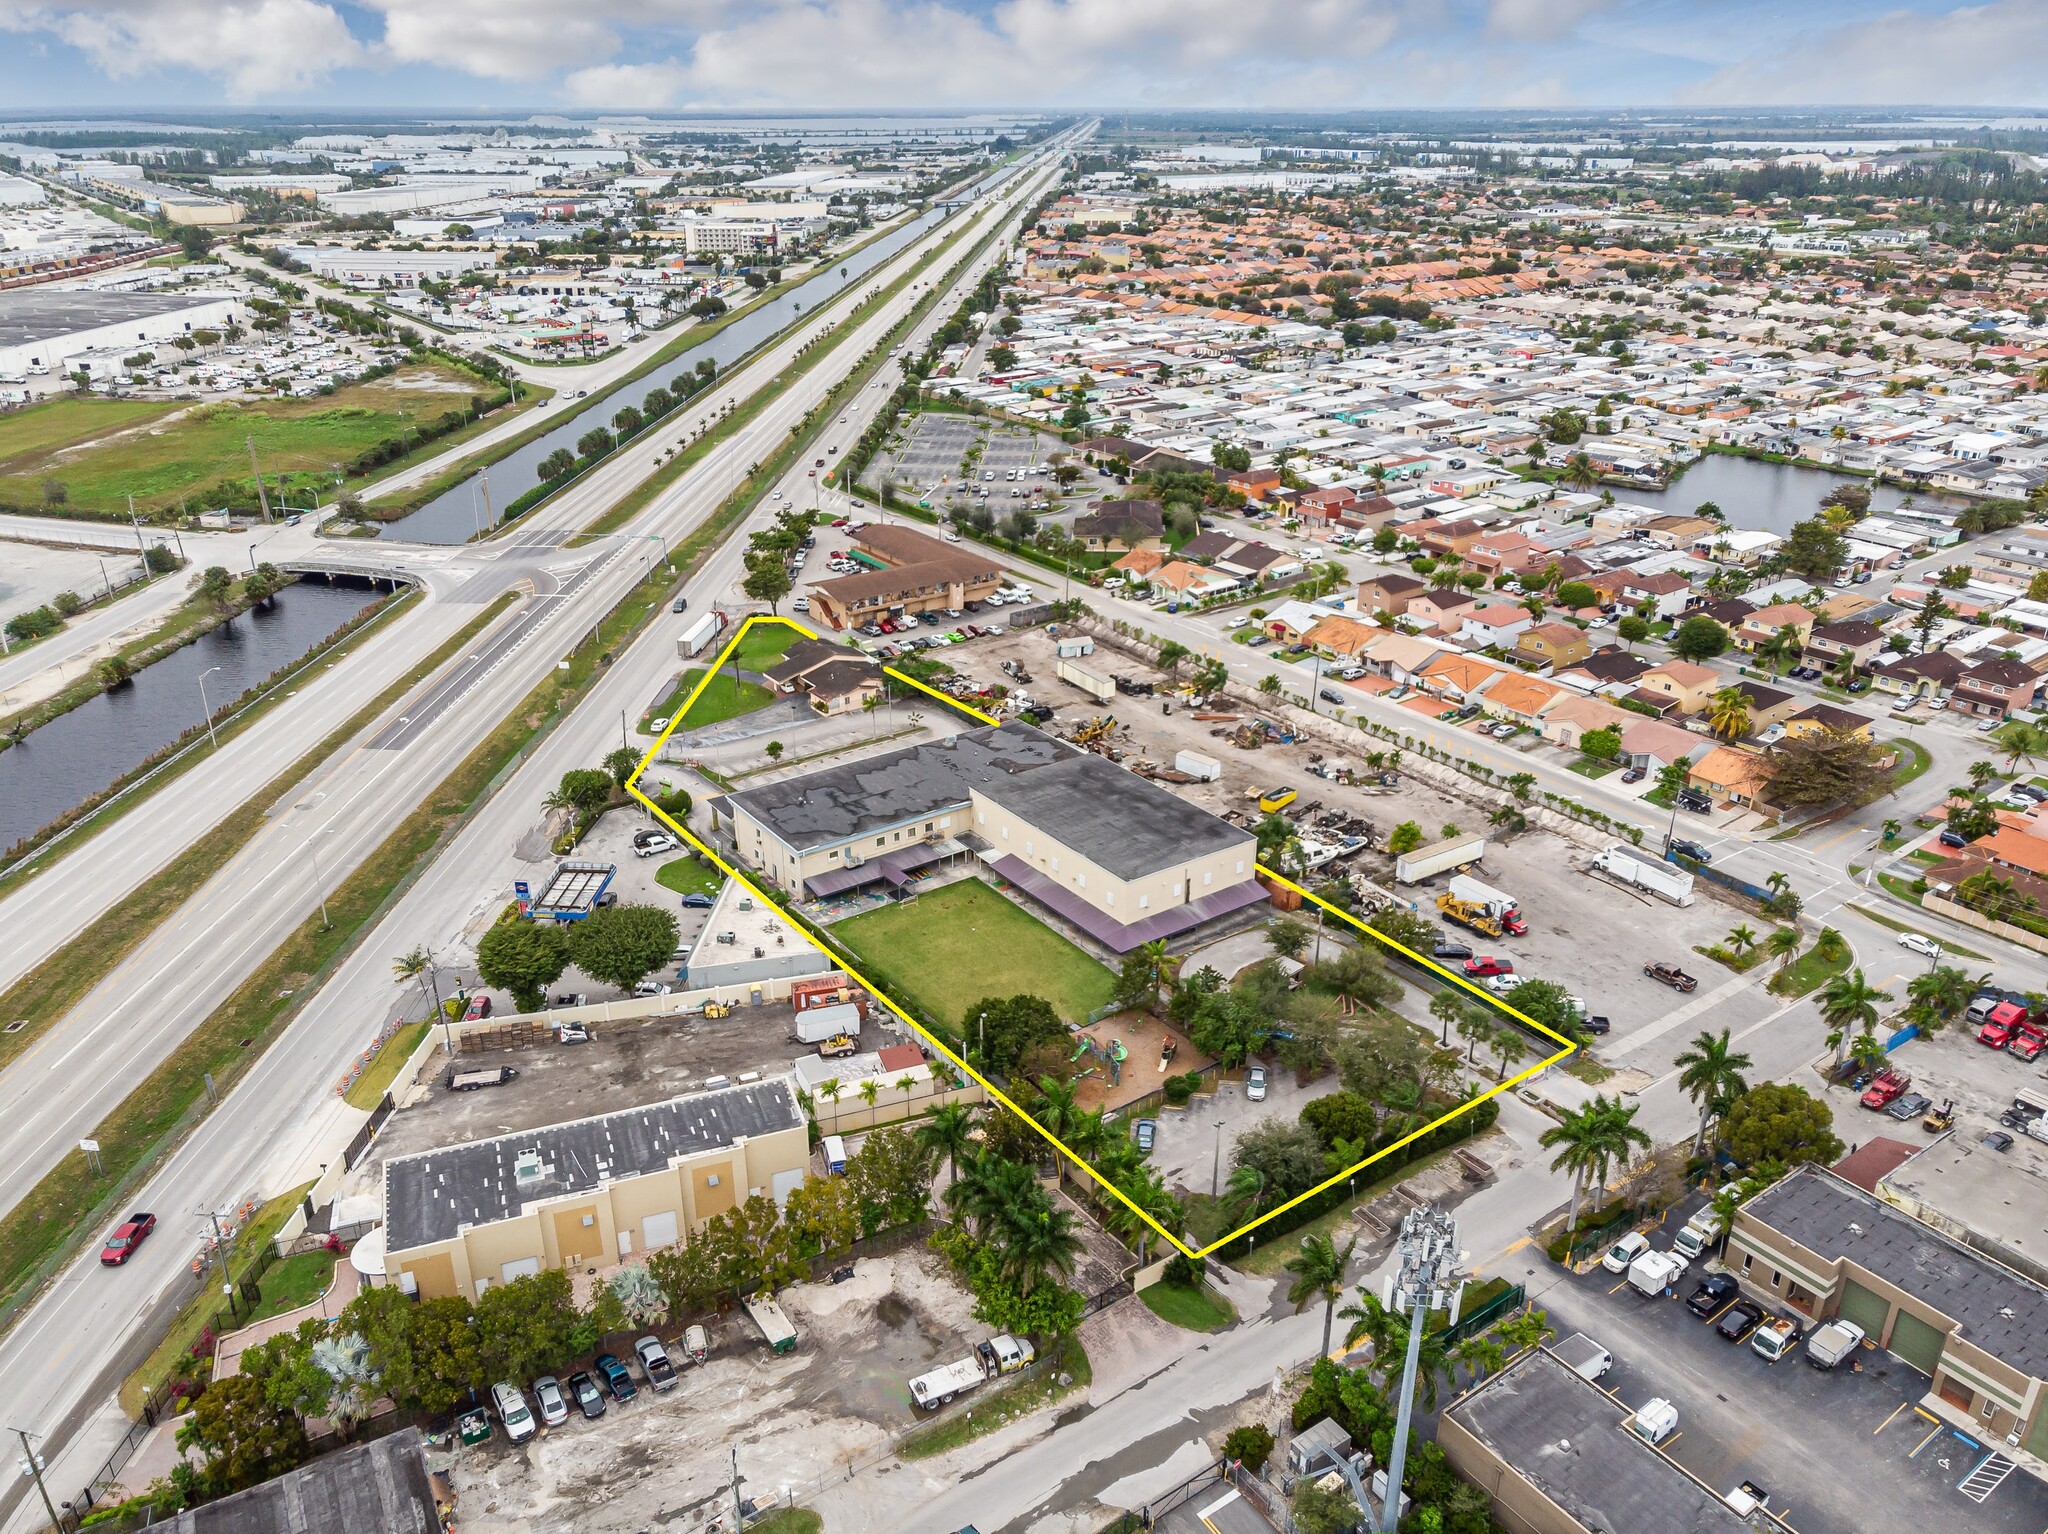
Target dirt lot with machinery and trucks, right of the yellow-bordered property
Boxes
[946,614,1759,1055]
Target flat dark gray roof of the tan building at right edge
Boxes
[1743,1167,2048,1380]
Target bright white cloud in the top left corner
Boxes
[0,0,362,100]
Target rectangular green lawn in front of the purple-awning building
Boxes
[831,879,1116,1024]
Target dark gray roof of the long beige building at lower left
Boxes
[385,1075,805,1251]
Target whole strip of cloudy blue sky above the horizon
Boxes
[0,0,2048,113]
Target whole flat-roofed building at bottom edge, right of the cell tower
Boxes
[1436,1348,1776,1534]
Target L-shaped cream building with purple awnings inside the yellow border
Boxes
[709,723,1266,952]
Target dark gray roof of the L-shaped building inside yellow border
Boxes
[731,723,1251,879]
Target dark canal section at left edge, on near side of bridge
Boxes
[0,580,381,848]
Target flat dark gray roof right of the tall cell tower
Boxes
[1444,1348,1755,1534]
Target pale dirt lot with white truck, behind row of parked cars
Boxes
[453,1245,987,1534]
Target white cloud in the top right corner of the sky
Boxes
[1681,0,2048,106]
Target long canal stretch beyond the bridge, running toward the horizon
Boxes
[383,166,1018,543]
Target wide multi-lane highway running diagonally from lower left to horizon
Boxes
[0,132,1081,1528]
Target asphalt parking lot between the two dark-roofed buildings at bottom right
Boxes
[1507,1241,2048,1534]
